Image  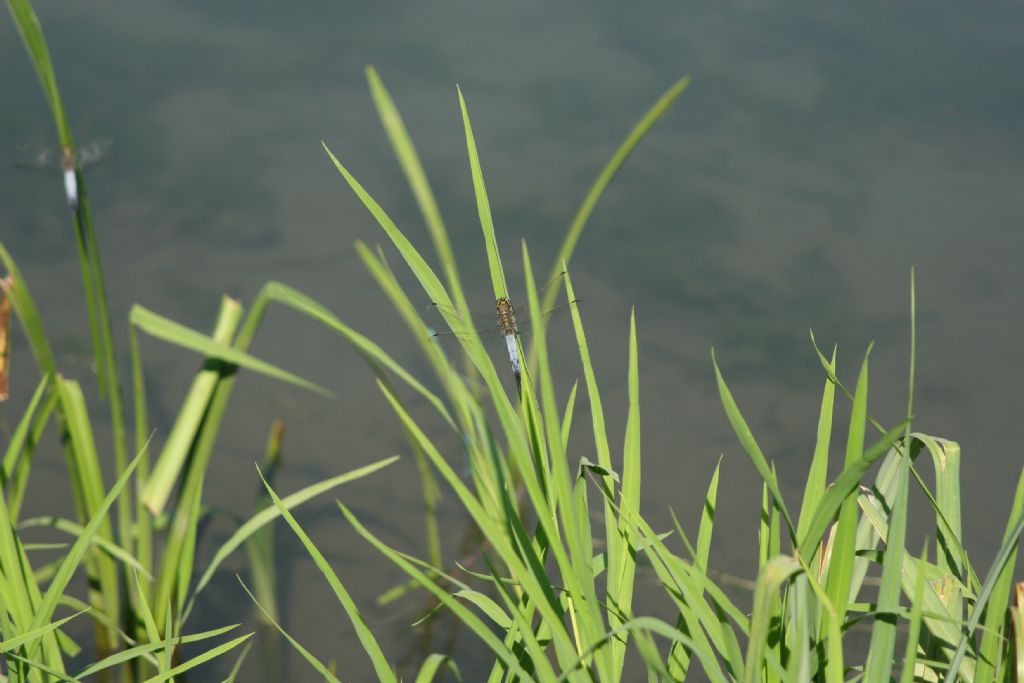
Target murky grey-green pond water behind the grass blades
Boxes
[0,0,1024,680]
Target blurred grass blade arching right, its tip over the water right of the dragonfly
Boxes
[542,76,690,310]
